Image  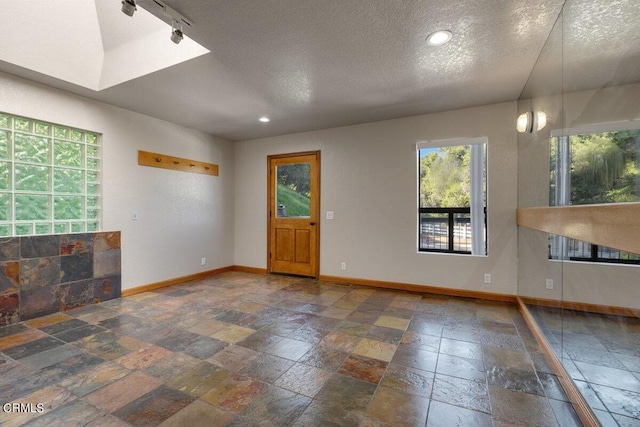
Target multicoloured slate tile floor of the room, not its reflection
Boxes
[0,272,580,427]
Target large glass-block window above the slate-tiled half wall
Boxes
[0,113,100,237]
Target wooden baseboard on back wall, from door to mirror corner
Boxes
[320,275,516,303]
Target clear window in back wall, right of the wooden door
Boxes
[417,138,487,255]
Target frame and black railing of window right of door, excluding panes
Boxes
[416,137,489,257]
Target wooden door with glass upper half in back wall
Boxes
[267,151,320,277]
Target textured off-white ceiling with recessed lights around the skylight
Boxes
[0,0,637,140]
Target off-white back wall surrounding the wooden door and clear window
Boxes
[234,102,517,294]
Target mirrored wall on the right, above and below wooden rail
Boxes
[514,0,640,426]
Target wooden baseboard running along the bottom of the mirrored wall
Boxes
[517,297,600,427]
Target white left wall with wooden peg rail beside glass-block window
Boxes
[0,73,234,289]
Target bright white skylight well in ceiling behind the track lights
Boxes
[0,0,209,91]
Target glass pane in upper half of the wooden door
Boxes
[276,162,311,218]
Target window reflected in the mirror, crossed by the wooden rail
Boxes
[549,124,640,264]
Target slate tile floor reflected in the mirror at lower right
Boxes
[528,306,640,427]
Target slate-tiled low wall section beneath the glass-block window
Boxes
[0,231,121,326]
